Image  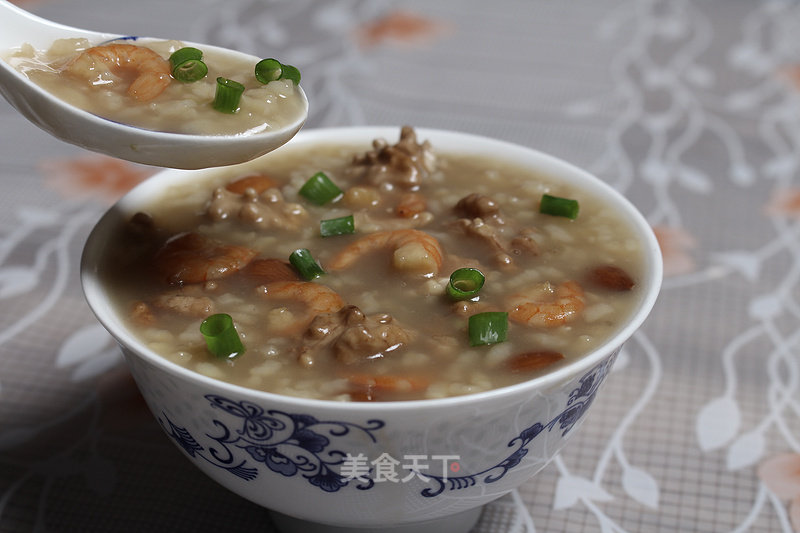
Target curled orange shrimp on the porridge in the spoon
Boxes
[66,43,172,102]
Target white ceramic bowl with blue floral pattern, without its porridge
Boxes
[81,127,662,533]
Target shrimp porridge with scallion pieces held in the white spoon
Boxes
[3,38,306,135]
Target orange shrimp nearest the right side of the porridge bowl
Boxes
[508,281,585,328]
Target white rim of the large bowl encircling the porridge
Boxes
[80,126,663,415]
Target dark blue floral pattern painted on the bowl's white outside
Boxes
[158,356,615,498]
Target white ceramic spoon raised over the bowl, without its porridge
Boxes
[0,0,308,169]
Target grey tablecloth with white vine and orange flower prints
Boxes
[0,0,800,532]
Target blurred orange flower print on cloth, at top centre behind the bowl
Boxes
[356,11,447,47]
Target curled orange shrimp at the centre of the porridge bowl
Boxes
[328,229,442,276]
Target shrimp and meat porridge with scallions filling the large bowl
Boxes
[97,127,652,401]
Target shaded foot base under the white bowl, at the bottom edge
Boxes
[270,507,482,533]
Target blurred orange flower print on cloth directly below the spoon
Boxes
[40,154,154,203]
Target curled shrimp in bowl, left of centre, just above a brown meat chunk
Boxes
[262,281,344,334]
